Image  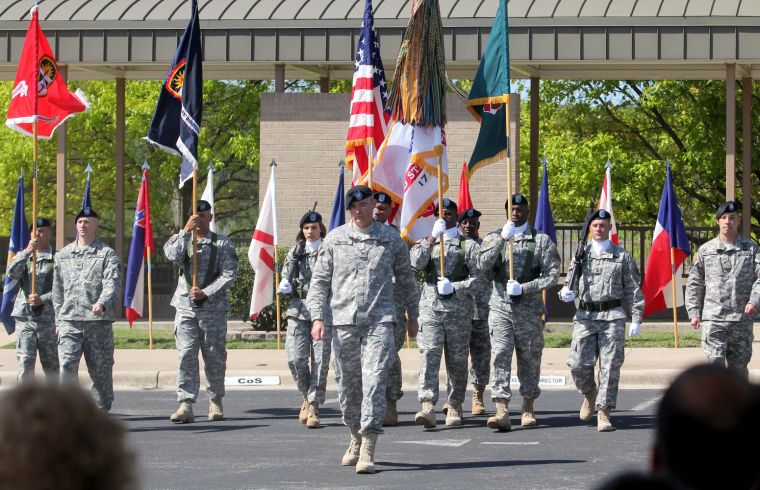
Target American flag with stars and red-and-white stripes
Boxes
[346,0,390,185]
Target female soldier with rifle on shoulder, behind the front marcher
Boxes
[277,211,332,429]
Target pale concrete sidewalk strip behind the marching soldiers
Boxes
[0,341,760,390]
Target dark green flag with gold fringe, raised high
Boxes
[467,0,509,176]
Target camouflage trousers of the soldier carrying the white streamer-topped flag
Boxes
[417,309,472,405]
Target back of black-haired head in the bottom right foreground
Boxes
[652,364,760,489]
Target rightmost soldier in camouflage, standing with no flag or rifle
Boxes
[686,201,760,377]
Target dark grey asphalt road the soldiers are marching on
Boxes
[112,389,661,489]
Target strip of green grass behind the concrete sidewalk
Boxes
[2,328,700,349]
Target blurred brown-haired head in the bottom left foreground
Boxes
[0,383,138,490]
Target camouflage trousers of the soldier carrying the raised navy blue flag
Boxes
[174,309,227,402]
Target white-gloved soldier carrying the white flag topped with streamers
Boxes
[409,198,484,428]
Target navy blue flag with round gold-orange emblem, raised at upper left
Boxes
[145,0,203,187]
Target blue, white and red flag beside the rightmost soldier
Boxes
[641,163,691,317]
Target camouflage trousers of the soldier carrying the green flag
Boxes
[488,306,544,400]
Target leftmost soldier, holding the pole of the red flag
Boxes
[7,218,58,382]
